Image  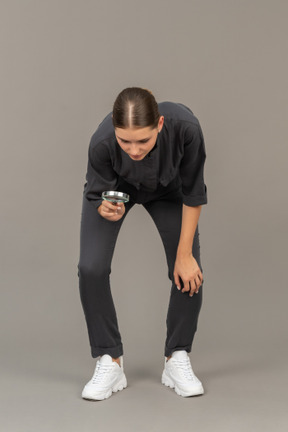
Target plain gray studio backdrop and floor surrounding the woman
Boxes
[0,0,288,432]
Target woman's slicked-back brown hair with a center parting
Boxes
[113,87,160,129]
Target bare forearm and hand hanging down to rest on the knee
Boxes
[174,204,203,296]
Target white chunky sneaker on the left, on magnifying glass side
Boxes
[82,354,127,400]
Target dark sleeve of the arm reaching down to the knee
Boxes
[180,122,207,207]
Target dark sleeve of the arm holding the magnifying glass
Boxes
[83,135,118,208]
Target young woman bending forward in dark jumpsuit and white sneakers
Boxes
[78,87,207,400]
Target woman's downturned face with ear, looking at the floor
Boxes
[115,116,164,161]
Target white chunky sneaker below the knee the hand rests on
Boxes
[161,350,204,397]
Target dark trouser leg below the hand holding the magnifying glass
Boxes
[78,196,133,358]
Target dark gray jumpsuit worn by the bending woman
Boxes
[78,102,207,358]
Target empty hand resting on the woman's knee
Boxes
[174,254,203,297]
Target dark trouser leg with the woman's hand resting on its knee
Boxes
[143,193,203,357]
